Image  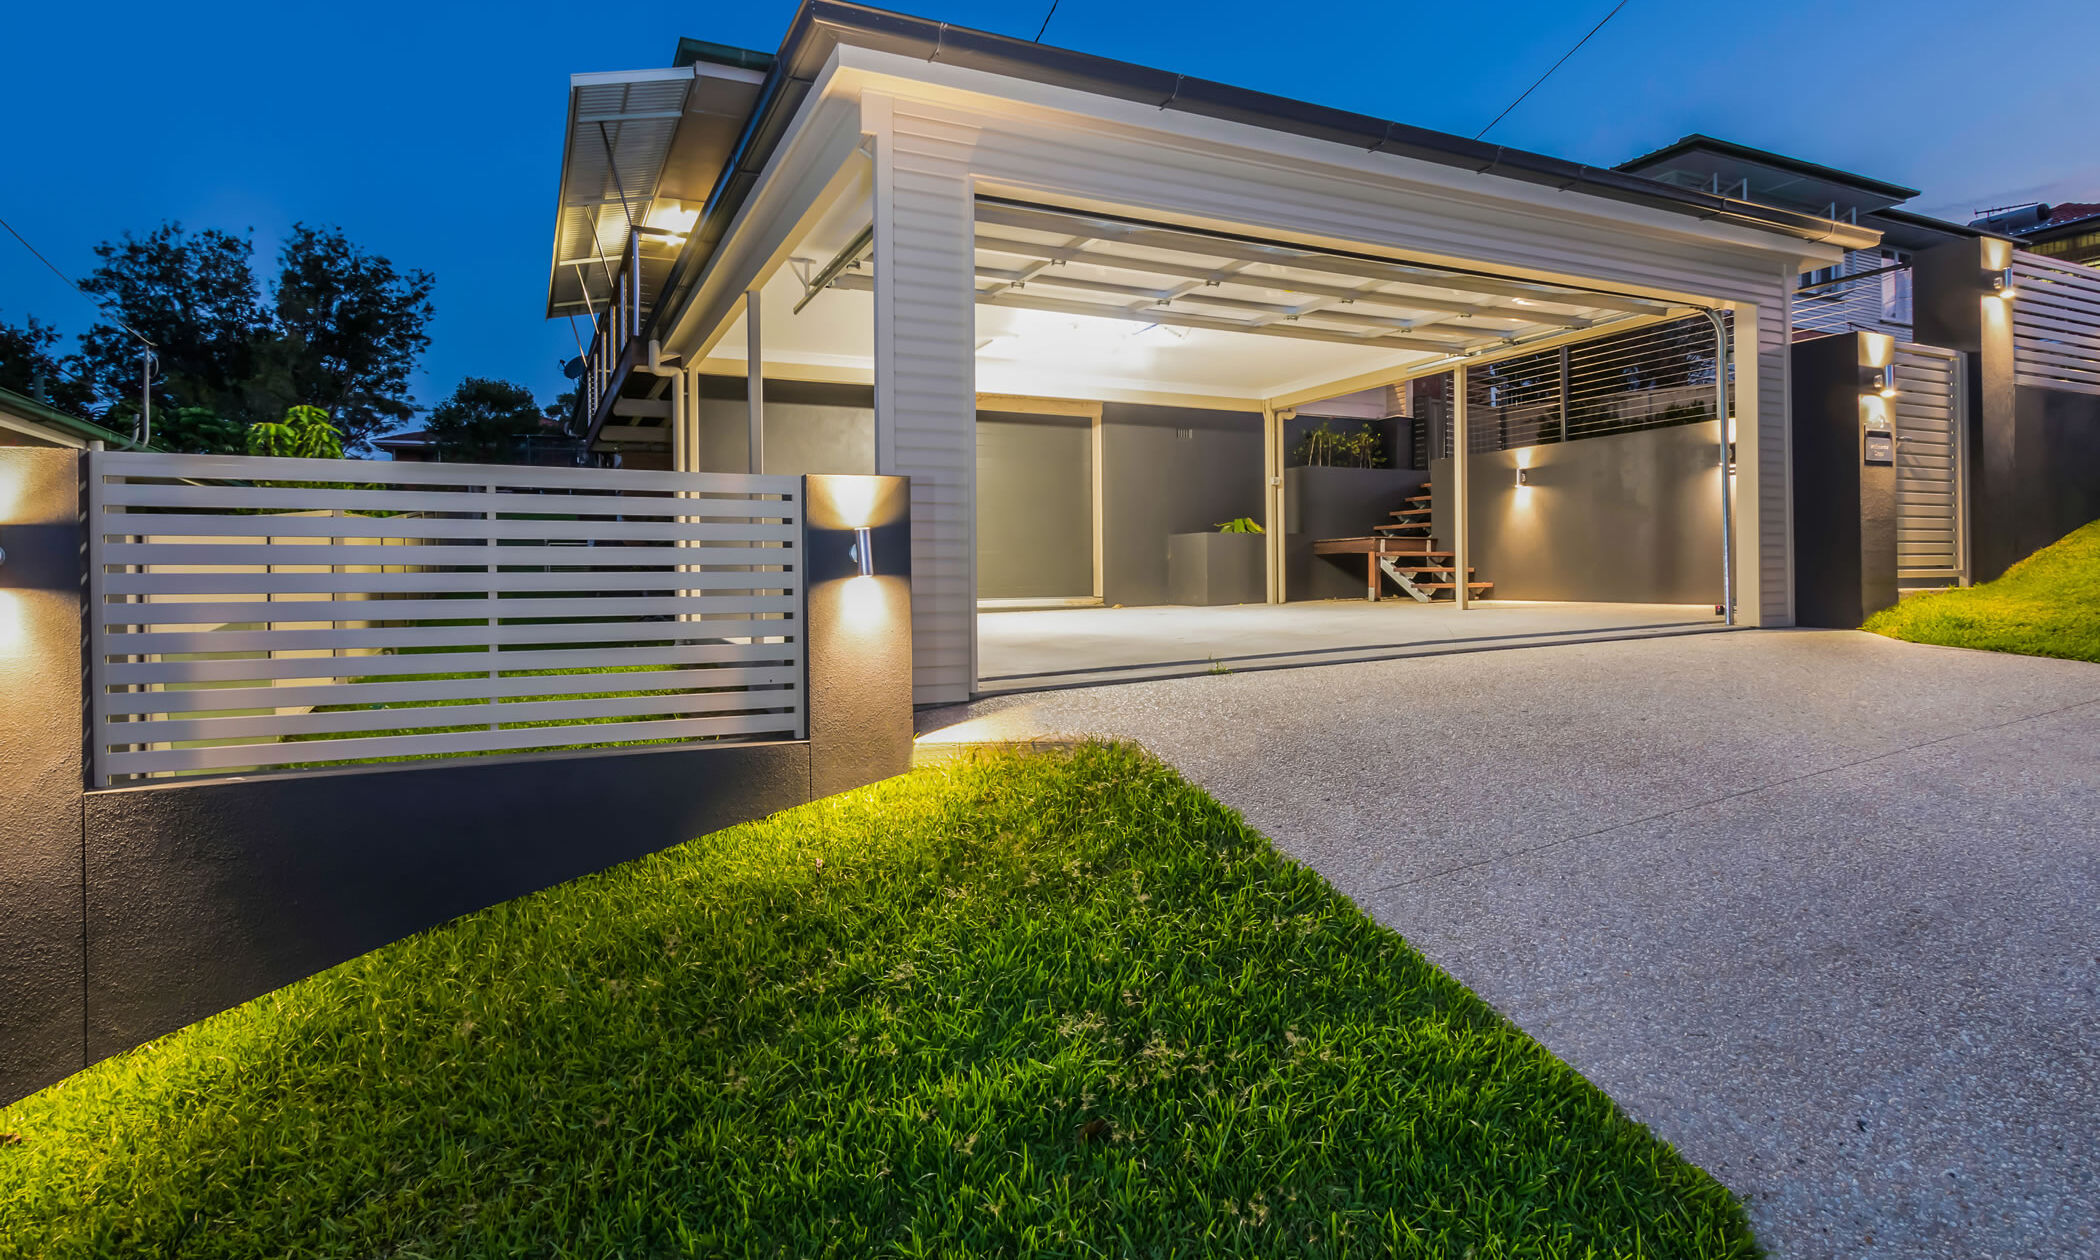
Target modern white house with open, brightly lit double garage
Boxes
[548,0,2100,704]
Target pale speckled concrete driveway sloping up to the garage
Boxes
[920,630,2100,1258]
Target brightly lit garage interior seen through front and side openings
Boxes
[605,189,1724,693]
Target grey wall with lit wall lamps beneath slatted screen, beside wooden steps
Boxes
[1432,424,1722,603]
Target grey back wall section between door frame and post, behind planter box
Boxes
[1100,403,1262,605]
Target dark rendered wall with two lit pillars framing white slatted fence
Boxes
[0,468,911,1100]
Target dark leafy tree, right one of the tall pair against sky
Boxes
[271,223,437,449]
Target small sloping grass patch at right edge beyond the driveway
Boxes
[1863,521,2100,662]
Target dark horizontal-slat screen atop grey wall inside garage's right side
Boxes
[1466,313,1733,454]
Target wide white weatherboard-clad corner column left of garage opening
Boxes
[861,92,977,704]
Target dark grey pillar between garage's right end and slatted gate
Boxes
[1791,332,1896,630]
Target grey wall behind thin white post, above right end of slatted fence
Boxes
[695,376,876,475]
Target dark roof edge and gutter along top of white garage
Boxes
[643,0,1864,432]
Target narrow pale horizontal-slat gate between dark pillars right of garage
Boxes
[1894,342,1964,582]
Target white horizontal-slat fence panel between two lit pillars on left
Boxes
[88,452,804,785]
